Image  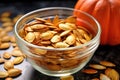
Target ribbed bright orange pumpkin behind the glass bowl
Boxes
[74,0,120,45]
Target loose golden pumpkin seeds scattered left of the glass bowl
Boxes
[0,11,25,80]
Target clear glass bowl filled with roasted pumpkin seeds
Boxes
[14,7,101,76]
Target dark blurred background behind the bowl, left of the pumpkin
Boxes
[0,0,77,13]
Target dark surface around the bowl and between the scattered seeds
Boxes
[0,0,120,80]
